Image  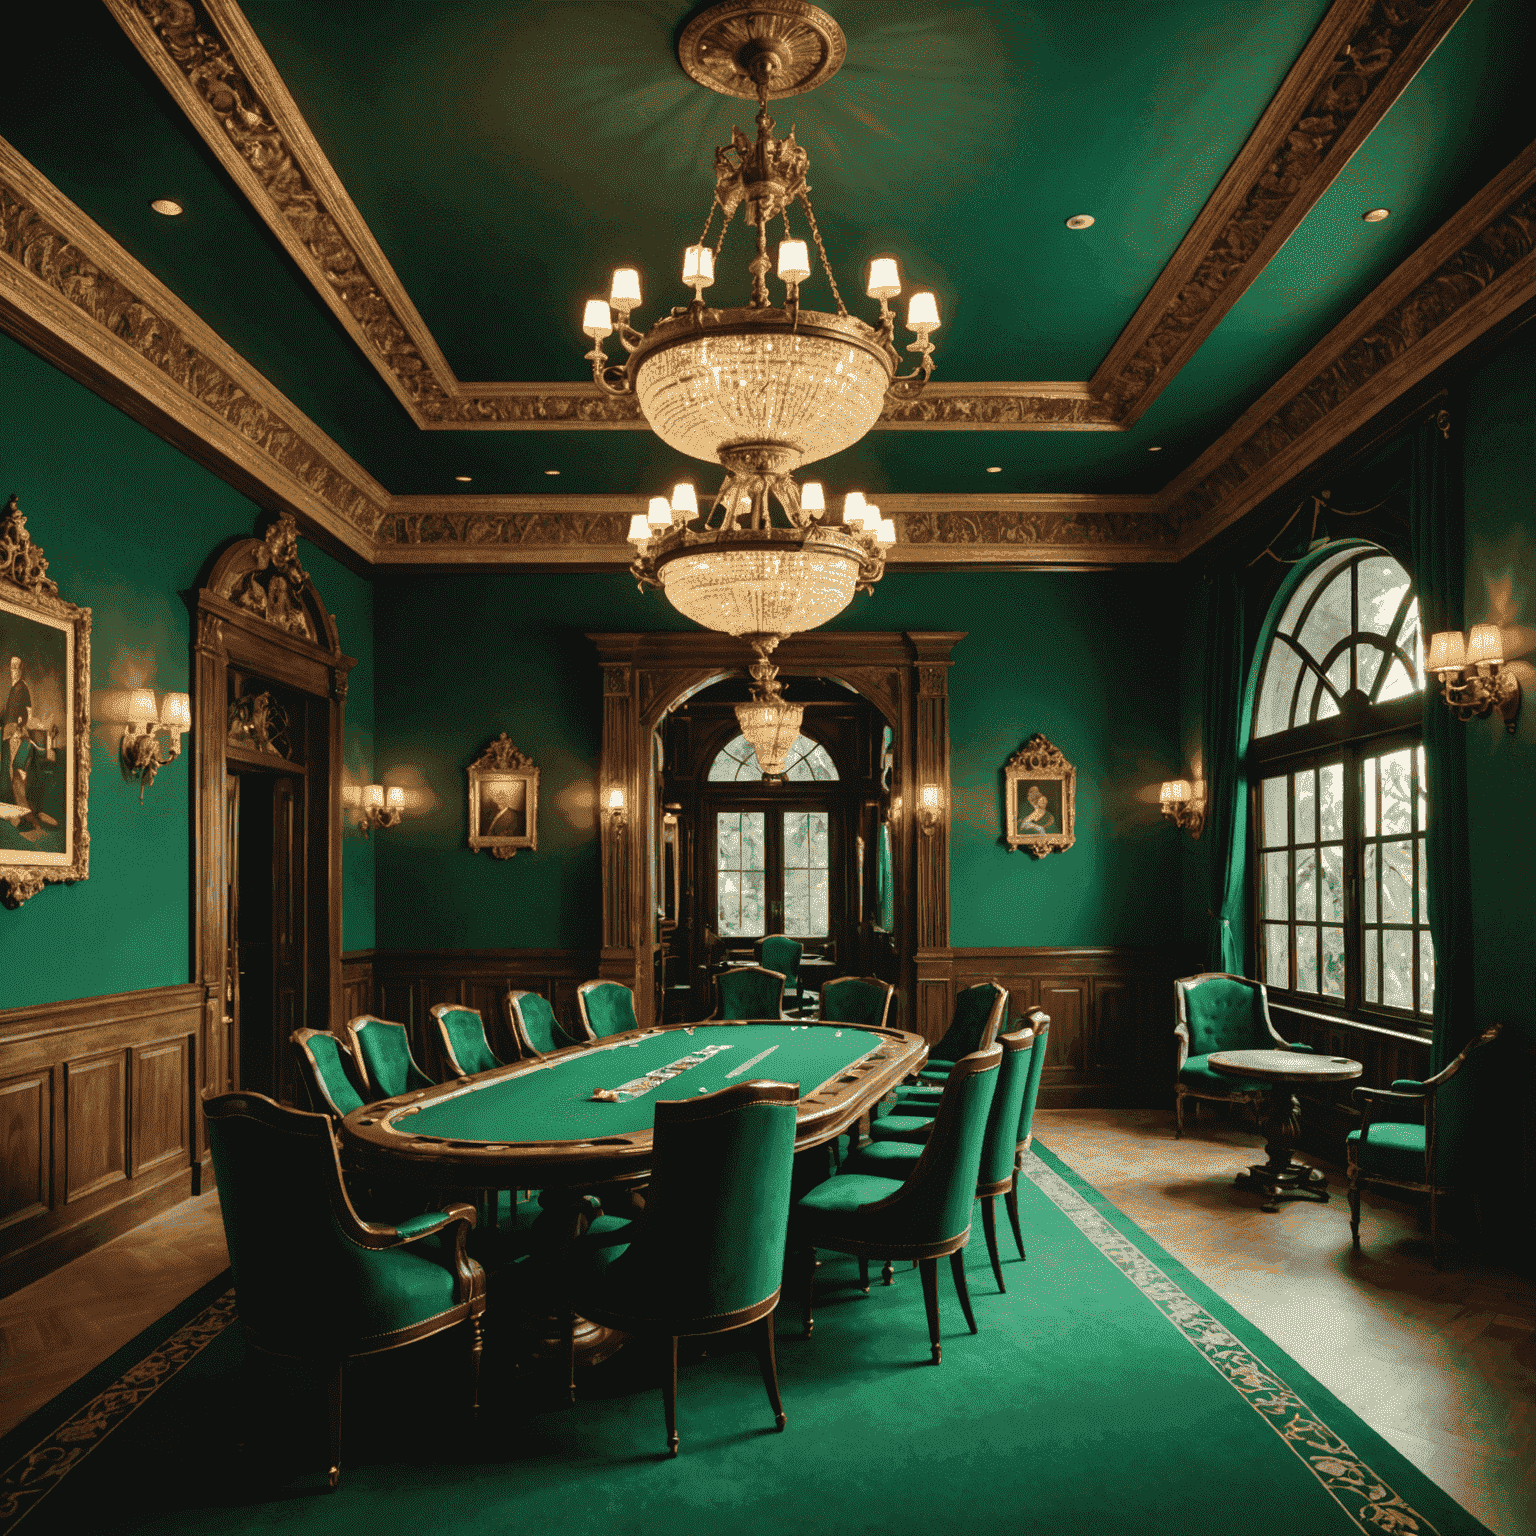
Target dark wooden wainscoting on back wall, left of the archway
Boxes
[362,949,598,1080]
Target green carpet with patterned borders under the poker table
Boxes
[0,1149,1485,1536]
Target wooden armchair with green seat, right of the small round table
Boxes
[1344,1025,1504,1266]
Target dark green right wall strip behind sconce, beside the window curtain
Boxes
[1461,317,1536,1041]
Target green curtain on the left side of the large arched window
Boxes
[1201,570,1247,975]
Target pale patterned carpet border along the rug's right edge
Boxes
[1021,1152,1438,1536]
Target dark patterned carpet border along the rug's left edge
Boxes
[0,1273,235,1536]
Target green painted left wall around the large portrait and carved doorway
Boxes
[0,336,373,1008]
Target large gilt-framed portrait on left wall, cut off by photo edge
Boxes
[0,496,91,911]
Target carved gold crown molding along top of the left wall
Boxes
[0,138,389,553]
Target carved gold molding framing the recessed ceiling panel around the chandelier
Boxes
[106,0,1449,445]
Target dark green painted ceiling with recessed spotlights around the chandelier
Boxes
[0,0,1536,493]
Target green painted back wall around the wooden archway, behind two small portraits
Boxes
[376,571,1181,948]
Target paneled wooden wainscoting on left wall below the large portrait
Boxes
[0,985,204,1296]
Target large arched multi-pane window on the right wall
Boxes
[1247,544,1435,1018]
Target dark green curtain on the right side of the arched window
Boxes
[1409,412,1475,1071]
